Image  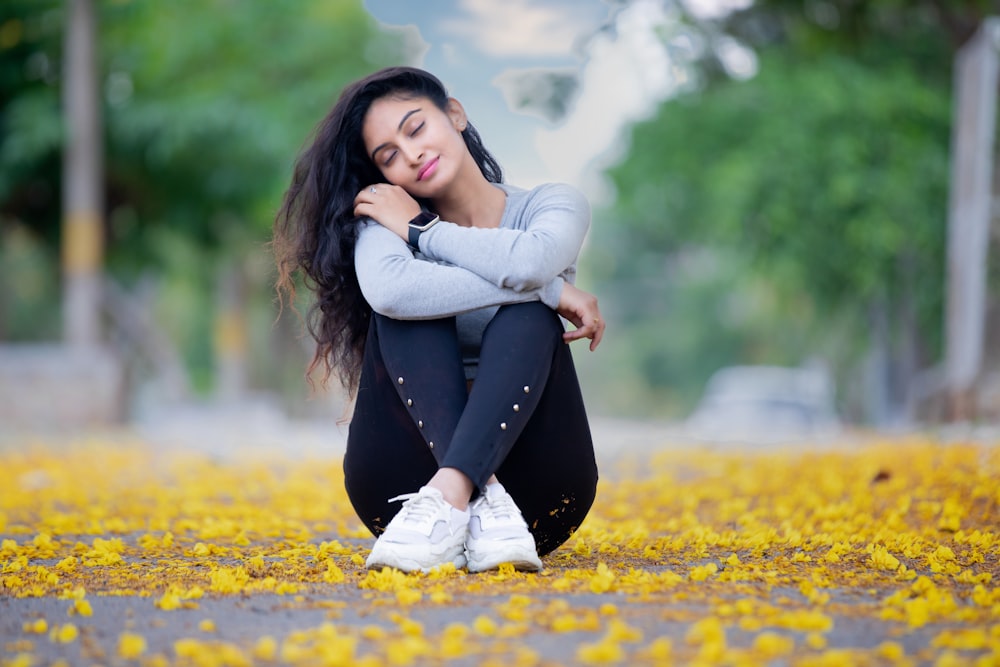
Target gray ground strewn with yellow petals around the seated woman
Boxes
[0,437,1000,667]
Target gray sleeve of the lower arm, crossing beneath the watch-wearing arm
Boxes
[354,222,563,320]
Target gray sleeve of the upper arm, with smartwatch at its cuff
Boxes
[420,184,590,292]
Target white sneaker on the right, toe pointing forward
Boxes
[465,482,542,572]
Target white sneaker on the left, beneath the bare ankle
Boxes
[365,486,469,572]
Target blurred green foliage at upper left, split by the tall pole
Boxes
[0,0,402,269]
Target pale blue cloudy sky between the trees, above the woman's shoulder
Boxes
[365,0,752,200]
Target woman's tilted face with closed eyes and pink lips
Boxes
[362,96,466,199]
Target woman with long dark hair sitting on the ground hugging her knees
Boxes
[274,67,604,572]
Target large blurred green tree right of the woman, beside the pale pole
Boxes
[589,0,989,420]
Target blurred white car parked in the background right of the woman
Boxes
[683,366,841,443]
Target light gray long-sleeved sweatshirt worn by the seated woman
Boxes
[354,183,590,378]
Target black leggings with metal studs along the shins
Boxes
[344,302,597,555]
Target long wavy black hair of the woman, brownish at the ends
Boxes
[271,67,503,395]
